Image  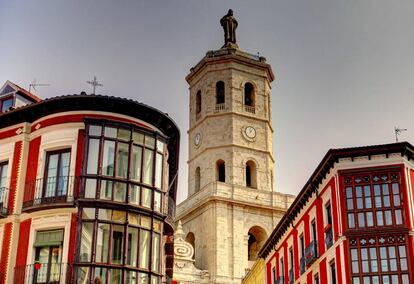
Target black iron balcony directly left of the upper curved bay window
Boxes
[23,176,79,211]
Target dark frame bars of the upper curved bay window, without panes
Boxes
[81,120,168,213]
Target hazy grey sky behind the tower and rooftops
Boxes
[0,0,414,201]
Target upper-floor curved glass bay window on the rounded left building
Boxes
[84,125,166,212]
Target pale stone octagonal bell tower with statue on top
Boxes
[174,10,293,283]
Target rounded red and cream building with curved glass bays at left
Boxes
[0,81,180,284]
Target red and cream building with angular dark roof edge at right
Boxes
[260,143,414,284]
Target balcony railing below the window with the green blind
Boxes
[13,263,72,284]
